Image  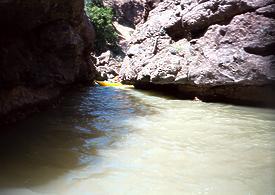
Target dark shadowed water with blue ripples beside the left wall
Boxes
[0,87,156,188]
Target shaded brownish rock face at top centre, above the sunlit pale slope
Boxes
[103,0,163,27]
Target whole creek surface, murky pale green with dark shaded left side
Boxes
[0,87,275,195]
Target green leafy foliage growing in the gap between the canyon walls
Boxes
[85,0,118,49]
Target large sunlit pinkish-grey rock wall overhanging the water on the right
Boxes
[120,0,275,105]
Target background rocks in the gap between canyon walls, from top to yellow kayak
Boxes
[95,0,161,81]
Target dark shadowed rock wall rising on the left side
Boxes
[0,0,95,121]
